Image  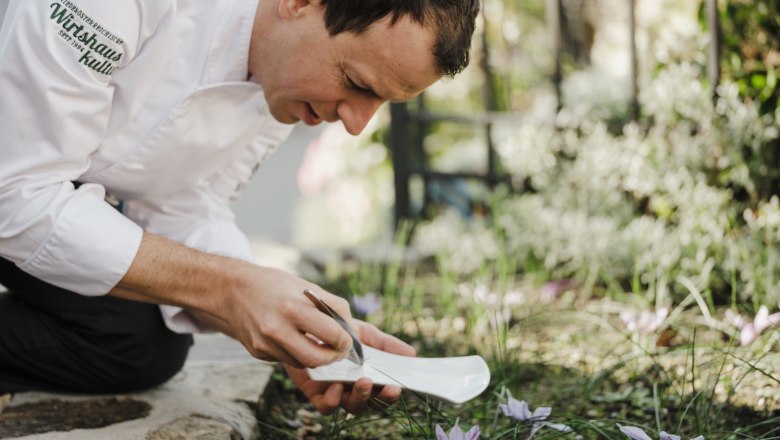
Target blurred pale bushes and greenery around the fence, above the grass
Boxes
[296,0,780,311]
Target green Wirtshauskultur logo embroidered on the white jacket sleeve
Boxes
[49,0,124,75]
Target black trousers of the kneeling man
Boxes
[0,258,192,394]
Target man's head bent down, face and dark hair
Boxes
[249,0,478,134]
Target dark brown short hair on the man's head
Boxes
[322,0,479,76]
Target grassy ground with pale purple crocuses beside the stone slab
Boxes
[258,251,780,439]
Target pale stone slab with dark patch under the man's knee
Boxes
[0,334,273,440]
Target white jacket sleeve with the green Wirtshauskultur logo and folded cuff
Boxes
[0,0,171,295]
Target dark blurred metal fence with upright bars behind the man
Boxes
[388,0,721,225]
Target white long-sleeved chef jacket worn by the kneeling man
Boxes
[0,0,291,332]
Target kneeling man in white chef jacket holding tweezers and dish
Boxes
[0,0,478,413]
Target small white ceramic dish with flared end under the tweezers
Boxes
[308,345,490,404]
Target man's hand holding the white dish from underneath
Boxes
[284,320,416,414]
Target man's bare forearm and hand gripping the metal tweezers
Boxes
[111,233,352,368]
